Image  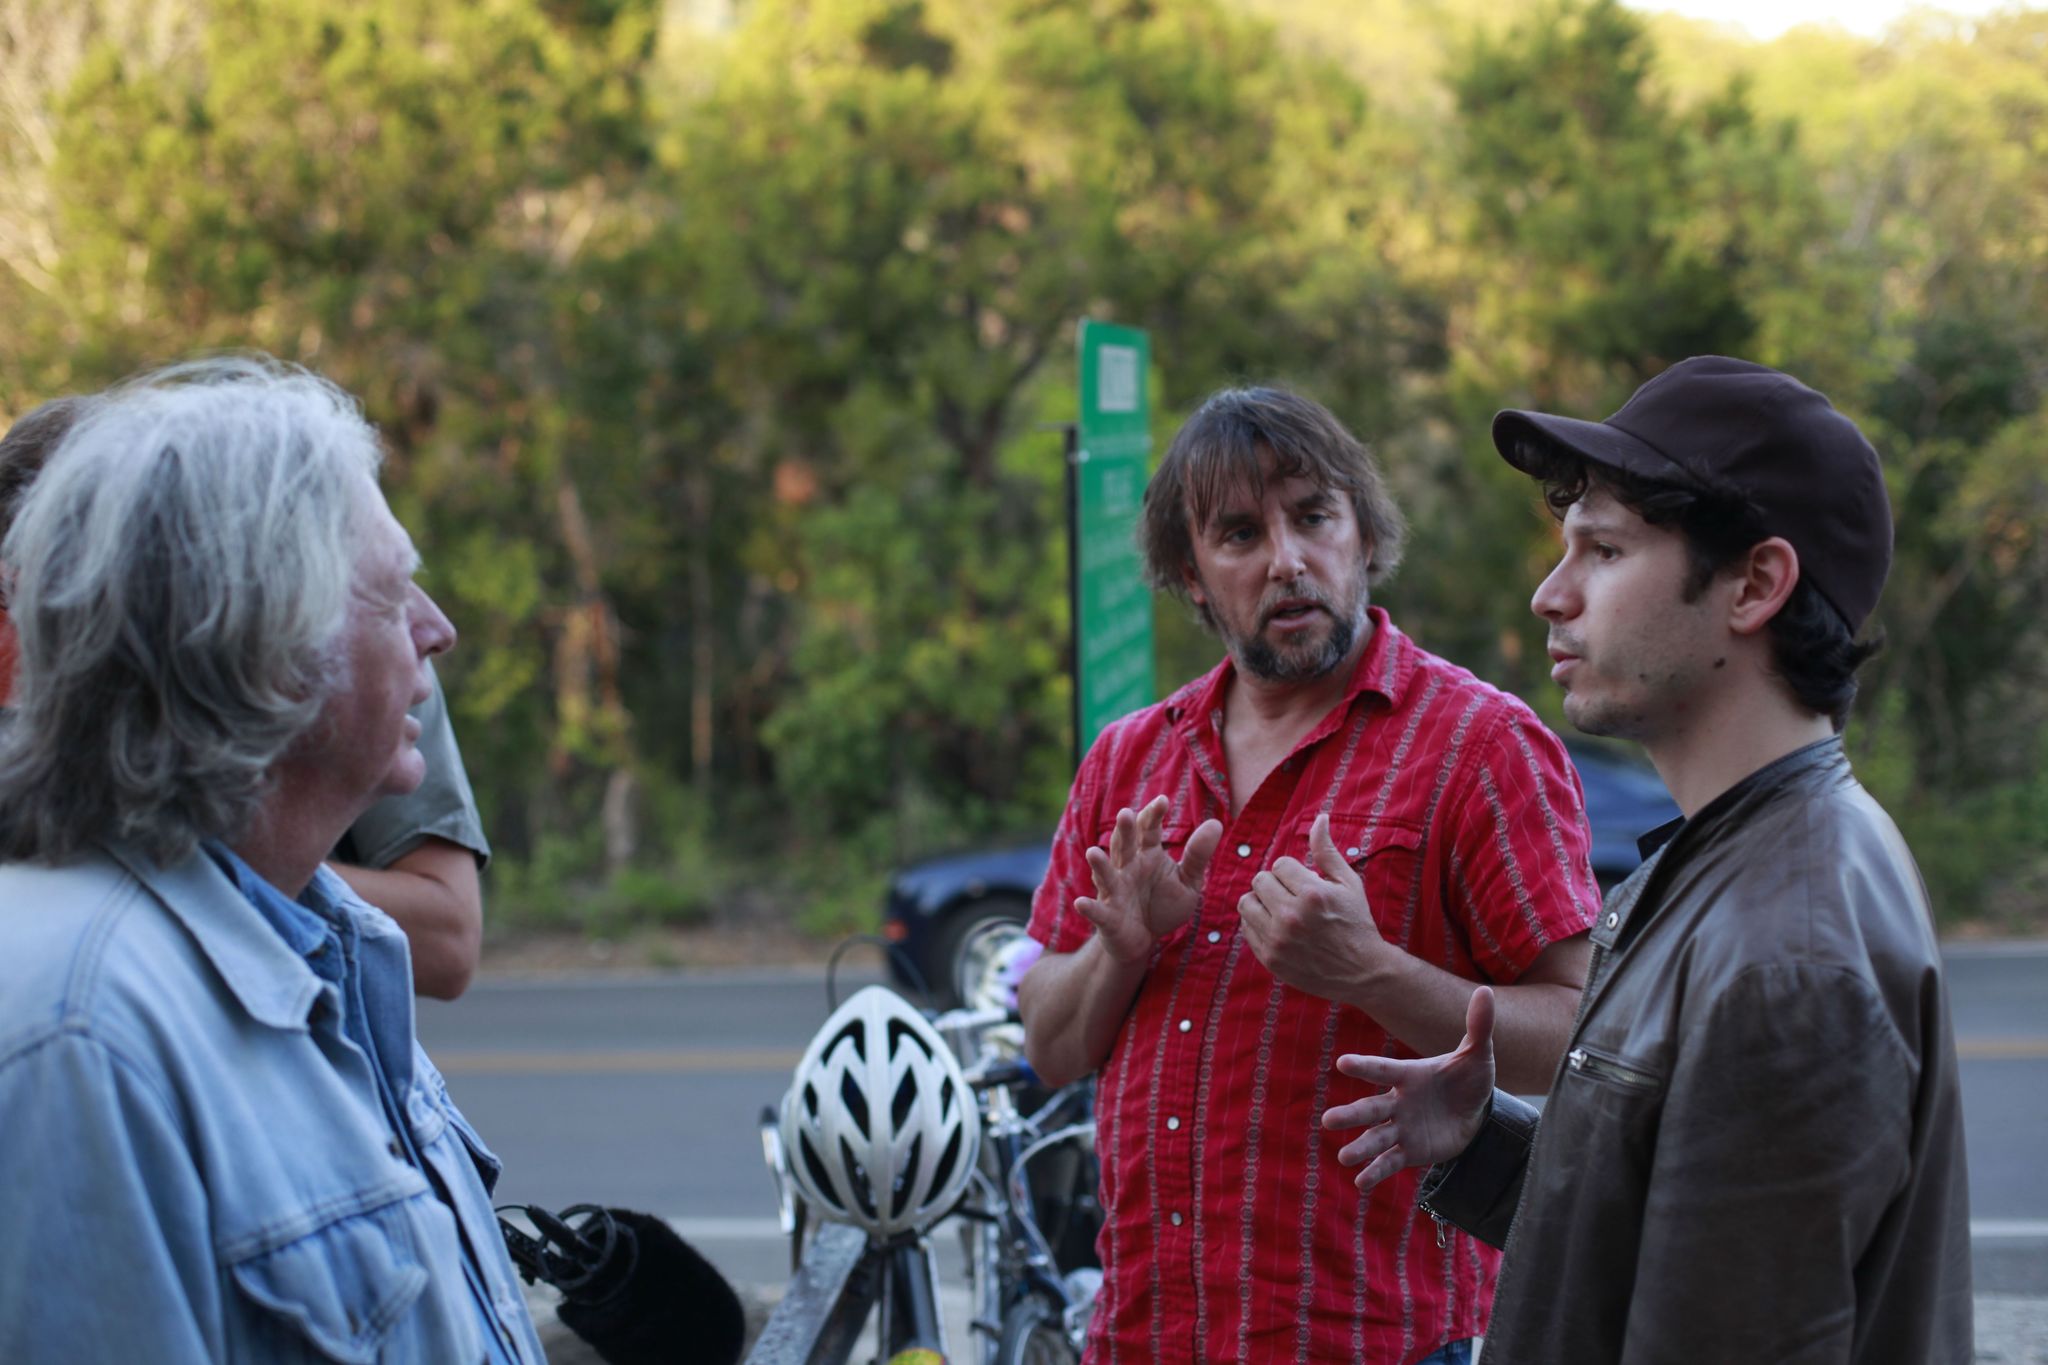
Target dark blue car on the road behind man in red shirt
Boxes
[883,739,1677,1009]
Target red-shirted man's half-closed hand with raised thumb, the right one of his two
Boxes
[1237,814,1386,1009]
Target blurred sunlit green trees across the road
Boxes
[0,0,2048,931]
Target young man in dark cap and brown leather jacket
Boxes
[1323,356,1972,1365]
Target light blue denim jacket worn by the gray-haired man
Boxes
[0,847,545,1365]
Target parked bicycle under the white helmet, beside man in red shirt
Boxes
[748,941,1102,1365]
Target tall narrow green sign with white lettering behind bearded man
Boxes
[1067,319,1153,757]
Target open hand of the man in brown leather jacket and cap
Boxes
[1323,986,1493,1191]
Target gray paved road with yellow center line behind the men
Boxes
[420,943,2048,1297]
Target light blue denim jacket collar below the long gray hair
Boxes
[106,841,322,1029]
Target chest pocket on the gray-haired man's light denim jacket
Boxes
[227,1191,483,1365]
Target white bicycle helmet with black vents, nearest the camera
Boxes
[782,986,981,1238]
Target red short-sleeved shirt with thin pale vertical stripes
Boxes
[1030,608,1599,1365]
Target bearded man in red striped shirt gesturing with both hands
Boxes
[1018,389,1599,1365]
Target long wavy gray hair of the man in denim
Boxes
[0,356,379,864]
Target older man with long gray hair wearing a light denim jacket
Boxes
[0,360,543,1365]
